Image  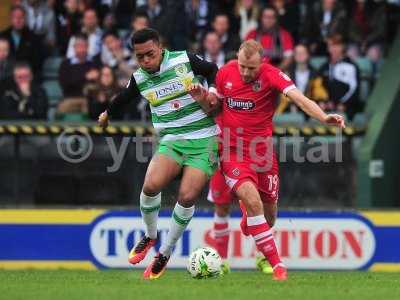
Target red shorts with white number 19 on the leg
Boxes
[221,153,279,203]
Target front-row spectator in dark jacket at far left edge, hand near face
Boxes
[0,63,48,120]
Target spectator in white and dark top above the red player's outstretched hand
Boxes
[319,34,360,119]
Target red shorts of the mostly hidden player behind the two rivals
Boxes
[207,169,233,205]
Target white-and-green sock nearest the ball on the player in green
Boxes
[160,202,194,257]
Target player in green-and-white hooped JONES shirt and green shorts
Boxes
[99,29,219,279]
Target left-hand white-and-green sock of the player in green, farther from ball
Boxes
[140,191,161,239]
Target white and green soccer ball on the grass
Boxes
[187,247,222,279]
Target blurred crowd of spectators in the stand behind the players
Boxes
[0,0,400,120]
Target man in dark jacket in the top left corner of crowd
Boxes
[0,6,42,74]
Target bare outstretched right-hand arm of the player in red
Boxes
[286,89,346,128]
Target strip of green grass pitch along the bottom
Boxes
[0,270,400,300]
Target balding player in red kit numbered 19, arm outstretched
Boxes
[190,40,345,280]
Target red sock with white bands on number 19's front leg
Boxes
[247,215,281,267]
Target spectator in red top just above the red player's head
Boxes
[246,6,294,70]
